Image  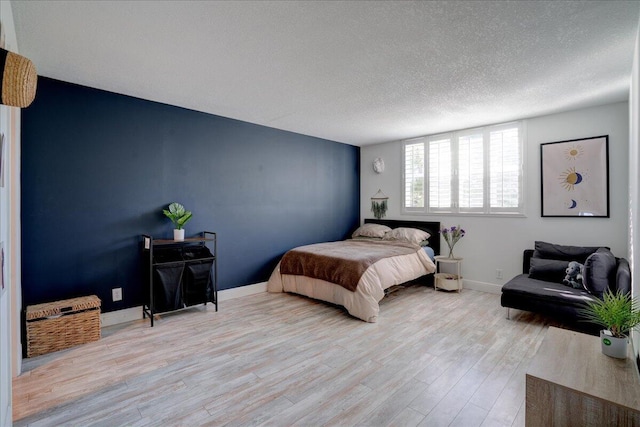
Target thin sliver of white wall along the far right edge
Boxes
[629,15,640,364]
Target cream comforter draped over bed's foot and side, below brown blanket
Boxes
[267,242,436,323]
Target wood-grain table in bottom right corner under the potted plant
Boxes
[525,327,640,427]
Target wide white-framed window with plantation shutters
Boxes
[403,122,524,214]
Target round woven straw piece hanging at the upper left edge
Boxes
[0,49,38,108]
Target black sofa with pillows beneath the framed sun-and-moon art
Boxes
[501,242,631,334]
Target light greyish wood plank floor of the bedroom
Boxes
[13,285,548,427]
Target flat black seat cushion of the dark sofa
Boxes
[502,274,595,308]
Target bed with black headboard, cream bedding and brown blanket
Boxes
[267,219,440,323]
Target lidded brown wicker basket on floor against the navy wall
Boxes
[26,295,100,357]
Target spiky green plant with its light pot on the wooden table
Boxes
[581,291,640,359]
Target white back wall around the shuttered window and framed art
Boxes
[360,102,629,291]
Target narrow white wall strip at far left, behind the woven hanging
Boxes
[0,0,22,426]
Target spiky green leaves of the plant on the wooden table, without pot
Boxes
[580,291,640,338]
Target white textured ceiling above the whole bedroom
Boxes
[11,0,640,145]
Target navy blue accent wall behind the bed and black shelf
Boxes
[22,77,360,311]
